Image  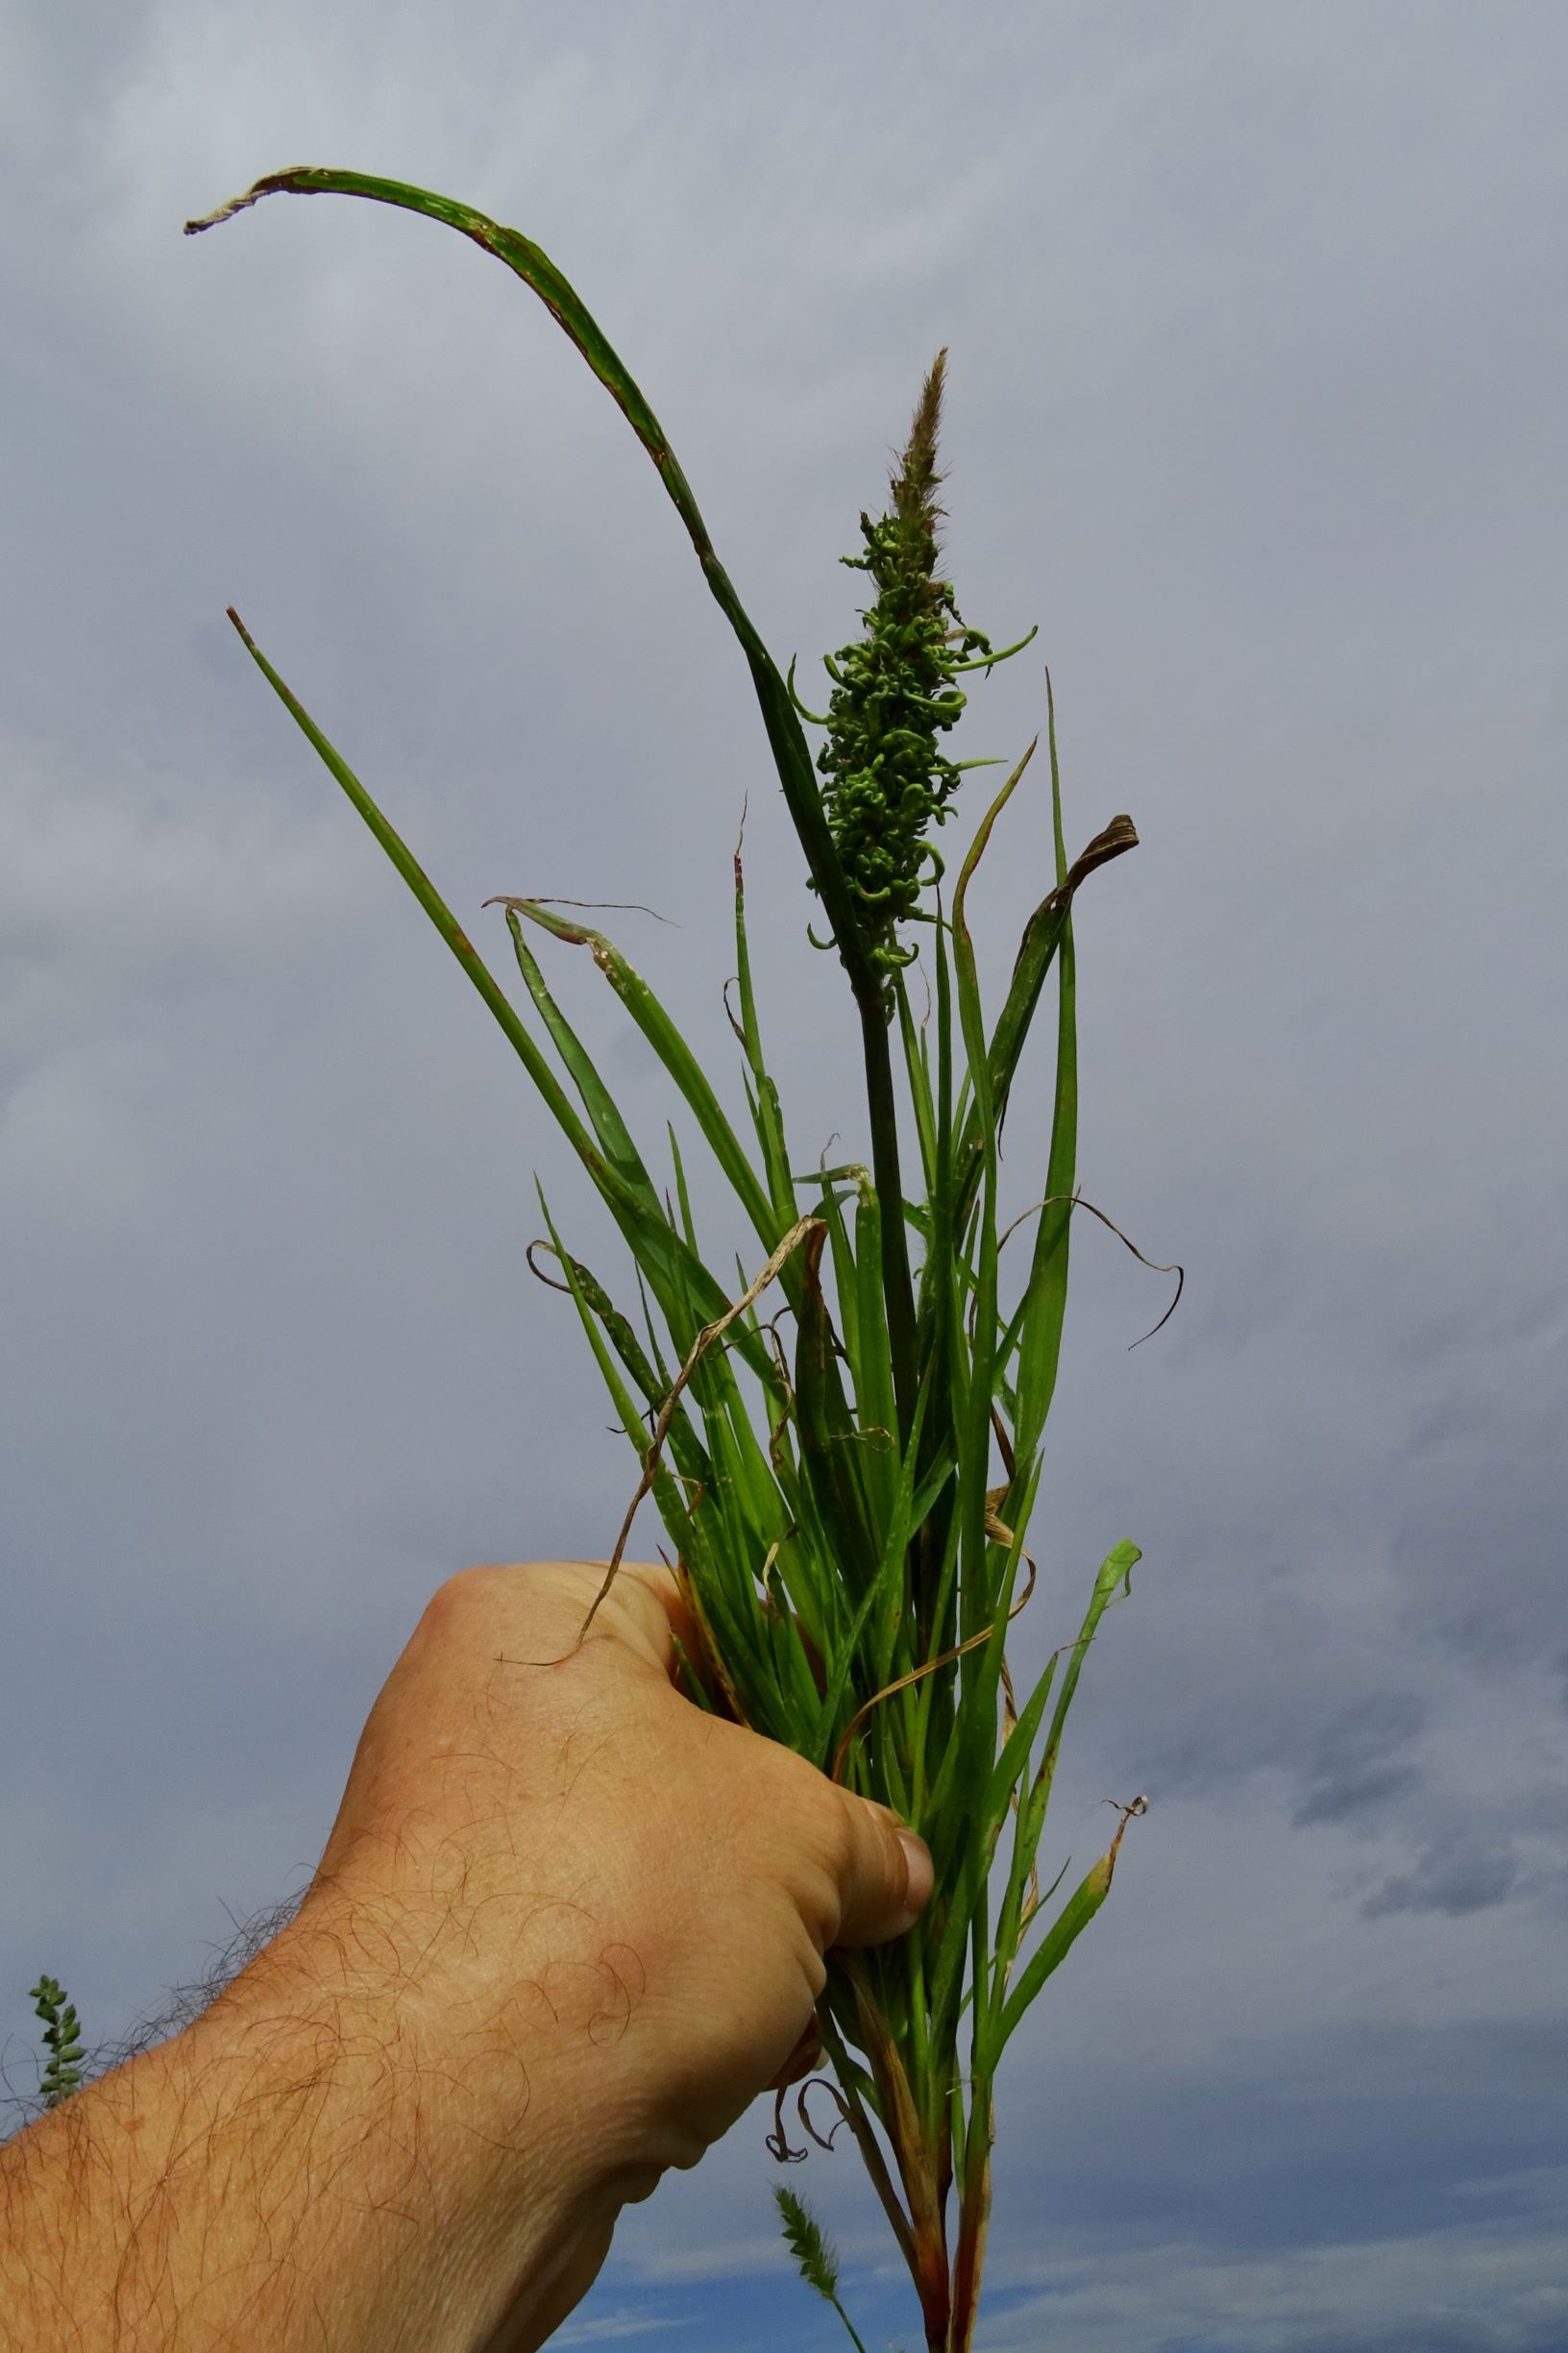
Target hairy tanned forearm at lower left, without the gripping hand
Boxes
[0,1934,617,2353]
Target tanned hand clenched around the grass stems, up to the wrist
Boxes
[253,1562,930,2343]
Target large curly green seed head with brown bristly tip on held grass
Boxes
[817,351,992,971]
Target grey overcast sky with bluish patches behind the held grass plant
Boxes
[0,0,1568,2353]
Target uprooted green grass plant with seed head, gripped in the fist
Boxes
[188,169,1170,2353]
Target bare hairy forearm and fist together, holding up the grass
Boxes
[0,1562,930,2353]
